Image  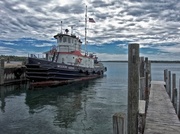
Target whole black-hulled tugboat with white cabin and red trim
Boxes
[26,7,107,82]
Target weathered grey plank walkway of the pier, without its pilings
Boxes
[144,81,180,134]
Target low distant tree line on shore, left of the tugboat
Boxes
[0,55,27,61]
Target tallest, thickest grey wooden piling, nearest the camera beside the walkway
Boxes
[127,44,139,134]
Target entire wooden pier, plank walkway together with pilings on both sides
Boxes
[113,44,180,134]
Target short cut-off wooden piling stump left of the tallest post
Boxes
[113,113,126,134]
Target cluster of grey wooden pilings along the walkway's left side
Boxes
[113,44,151,134]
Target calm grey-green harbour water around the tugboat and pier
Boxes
[0,62,180,134]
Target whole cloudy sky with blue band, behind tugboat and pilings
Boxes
[0,0,180,60]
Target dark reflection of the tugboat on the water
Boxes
[25,81,93,128]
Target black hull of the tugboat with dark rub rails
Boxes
[26,58,106,82]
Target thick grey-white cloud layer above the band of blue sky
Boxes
[0,0,180,58]
